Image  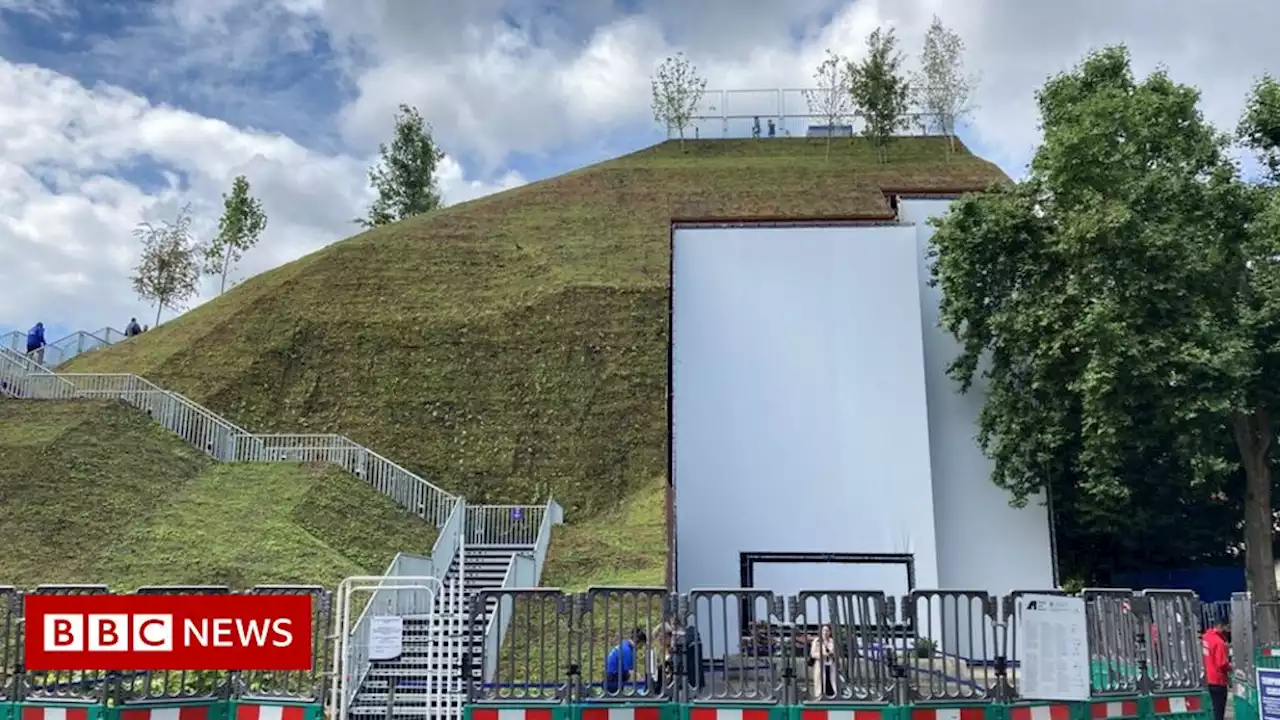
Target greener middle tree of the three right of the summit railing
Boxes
[849,28,911,163]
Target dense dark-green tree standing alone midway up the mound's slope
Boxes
[356,105,444,228]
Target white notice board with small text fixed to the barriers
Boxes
[1014,594,1090,696]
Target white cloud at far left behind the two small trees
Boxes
[0,60,524,327]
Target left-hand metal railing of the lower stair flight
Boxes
[343,497,467,706]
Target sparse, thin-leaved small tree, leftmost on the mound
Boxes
[131,205,202,325]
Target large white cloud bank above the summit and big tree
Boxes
[320,0,1280,169]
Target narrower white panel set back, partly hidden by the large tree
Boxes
[899,200,1053,594]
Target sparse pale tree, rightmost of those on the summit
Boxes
[911,15,978,155]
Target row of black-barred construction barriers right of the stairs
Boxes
[463,588,1212,720]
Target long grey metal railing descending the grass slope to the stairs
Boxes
[0,361,457,527]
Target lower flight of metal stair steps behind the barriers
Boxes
[347,544,534,720]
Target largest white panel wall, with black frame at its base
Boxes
[672,227,938,591]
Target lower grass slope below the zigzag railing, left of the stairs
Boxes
[0,401,435,589]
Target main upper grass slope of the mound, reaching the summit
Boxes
[70,138,1006,586]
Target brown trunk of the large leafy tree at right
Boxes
[1231,409,1280,643]
